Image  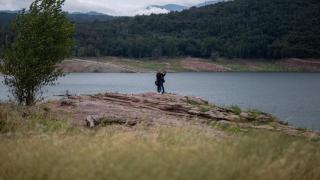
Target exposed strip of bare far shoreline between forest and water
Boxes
[58,57,320,73]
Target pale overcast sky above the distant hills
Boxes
[0,0,204,16]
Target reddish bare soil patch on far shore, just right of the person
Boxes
[181,58,230,72]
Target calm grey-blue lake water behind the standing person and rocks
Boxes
[0,73,320,130]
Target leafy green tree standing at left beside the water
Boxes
[0,0,74,106]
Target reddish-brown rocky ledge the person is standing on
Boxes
[53,92,320,138]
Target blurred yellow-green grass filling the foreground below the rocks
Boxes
[0,105,320,180]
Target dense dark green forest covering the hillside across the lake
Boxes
[1,0,320,59]
